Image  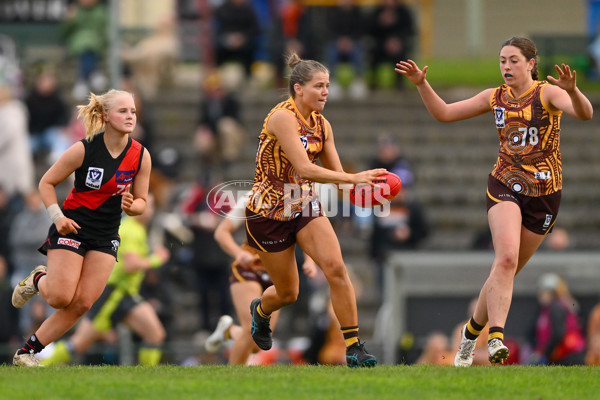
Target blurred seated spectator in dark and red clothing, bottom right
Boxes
[530,273,586,365]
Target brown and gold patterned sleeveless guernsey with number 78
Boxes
[490,81,562,197]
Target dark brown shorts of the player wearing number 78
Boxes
[487,175,562,235]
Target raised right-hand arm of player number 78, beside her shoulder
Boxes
[544,64,594,120]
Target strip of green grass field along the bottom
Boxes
[0,365,600,400]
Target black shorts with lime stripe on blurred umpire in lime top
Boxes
[86,285,144,332]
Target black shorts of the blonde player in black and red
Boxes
[38,224,121,259]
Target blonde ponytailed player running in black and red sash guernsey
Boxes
[12,90,151,367]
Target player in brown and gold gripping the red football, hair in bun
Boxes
[246,53,386,367]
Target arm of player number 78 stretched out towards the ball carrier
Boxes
[395,60,492,122]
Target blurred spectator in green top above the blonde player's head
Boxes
[61,0,109,100]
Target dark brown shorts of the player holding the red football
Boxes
[246,202,323,253]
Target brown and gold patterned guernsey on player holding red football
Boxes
[247,97,328,221]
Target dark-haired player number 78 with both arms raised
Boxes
[396,37,593,366]
